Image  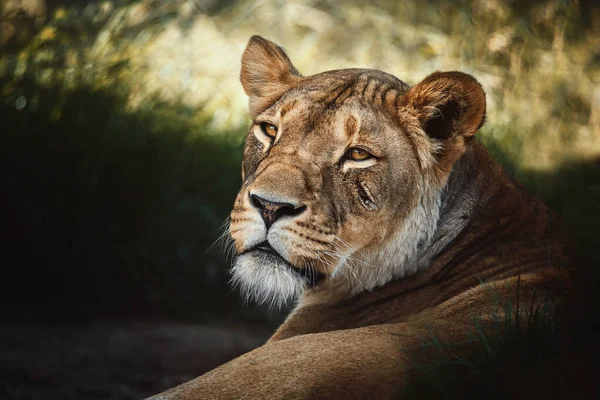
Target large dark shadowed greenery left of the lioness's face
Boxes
[0,74,248,320]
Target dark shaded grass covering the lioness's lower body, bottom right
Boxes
[400,282,593,399]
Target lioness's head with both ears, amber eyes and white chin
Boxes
[229,37,485,304]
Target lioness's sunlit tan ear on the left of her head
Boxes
[240,35,301,117]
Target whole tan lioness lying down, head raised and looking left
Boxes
[153,36,570,399]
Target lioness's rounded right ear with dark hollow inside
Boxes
[403,72,485,140]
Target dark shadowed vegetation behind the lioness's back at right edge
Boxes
[519,158,600,398]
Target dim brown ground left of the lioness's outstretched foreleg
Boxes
[0,321,269,400]
